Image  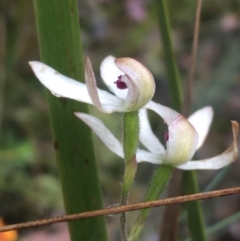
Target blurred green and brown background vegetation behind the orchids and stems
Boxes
[0,0,240,241]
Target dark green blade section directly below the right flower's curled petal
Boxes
[183,171,206,241]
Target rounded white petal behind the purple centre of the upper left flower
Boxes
[100,56,128,99]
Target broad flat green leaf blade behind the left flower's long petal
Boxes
[34,0,107,241]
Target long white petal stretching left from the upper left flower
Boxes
[29,61,124,113]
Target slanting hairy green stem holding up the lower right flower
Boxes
[127,165,173,241]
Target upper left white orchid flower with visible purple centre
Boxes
[29,56,155,113]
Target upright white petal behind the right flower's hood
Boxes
[188,106,213,149]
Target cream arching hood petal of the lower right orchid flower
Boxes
[145,101,198,165]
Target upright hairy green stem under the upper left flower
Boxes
[120,111,139,241]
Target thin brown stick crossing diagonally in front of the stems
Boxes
[0,187,240,232]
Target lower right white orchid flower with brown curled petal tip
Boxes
[75,101,238,170]
